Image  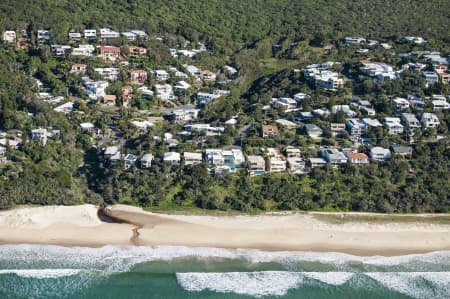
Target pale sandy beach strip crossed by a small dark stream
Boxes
[0,205,450,256]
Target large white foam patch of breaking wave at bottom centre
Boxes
[176,271,303,297]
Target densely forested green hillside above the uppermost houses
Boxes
[0,0,450,53]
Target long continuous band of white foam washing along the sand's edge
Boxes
[0,245,450,273]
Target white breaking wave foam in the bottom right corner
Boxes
[365,272,450,299]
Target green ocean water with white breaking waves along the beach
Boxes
[0,245,450,299]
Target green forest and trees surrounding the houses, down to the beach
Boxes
[0,0,450,213]
